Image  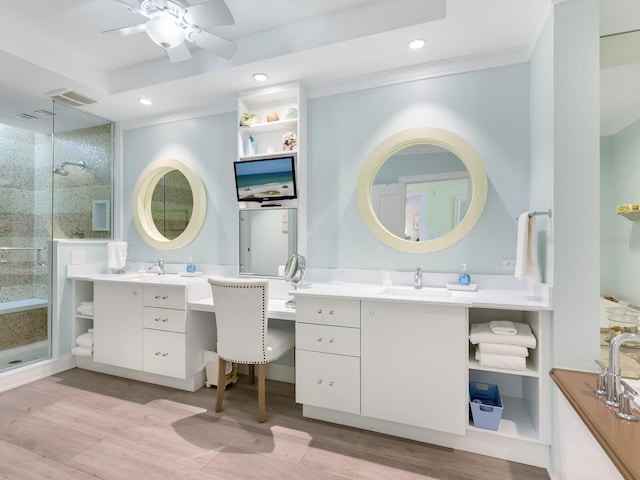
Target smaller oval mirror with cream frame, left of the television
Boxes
[133,159,207,250]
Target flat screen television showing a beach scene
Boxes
[233,155,297,202]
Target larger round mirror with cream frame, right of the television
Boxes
[356,127,488,253]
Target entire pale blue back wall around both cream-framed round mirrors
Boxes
[123,63,529,274]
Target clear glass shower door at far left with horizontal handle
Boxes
[0,101,53,371]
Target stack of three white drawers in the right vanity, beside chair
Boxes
[296,298,360,414]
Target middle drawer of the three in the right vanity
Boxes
[296,323,360,357]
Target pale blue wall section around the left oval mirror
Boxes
[122,112,238,266]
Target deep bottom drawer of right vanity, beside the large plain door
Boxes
[296,350,360,415]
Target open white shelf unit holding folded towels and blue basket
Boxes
[468,308,550,444]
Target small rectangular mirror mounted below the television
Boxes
[239,208,297,277]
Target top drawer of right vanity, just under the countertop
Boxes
[296,297,360,328]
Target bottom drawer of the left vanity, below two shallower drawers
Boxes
[143,329,186,378]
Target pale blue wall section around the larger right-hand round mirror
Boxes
[307,64,529,274]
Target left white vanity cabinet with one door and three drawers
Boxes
[80,278,216,391]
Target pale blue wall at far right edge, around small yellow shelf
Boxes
[600,121,640,304]
